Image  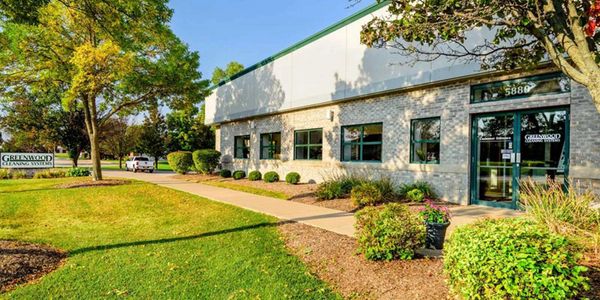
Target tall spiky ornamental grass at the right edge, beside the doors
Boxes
[519,178,600,253]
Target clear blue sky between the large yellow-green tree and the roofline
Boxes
[169,0,375,78]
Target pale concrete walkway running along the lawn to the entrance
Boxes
[104,171,521,237]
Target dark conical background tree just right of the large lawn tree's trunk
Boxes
[136,106,168,168]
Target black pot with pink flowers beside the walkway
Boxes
[419,201,450,250]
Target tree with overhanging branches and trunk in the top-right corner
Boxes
[359,0,600,111]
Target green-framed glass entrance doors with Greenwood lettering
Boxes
[471,108,569,209]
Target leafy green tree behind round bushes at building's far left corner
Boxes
[166,106,215,152]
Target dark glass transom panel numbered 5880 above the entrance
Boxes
[471,73,571,103]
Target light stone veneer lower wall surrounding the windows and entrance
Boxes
[217,71,600,204]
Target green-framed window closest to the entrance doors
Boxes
[410,117,440,164]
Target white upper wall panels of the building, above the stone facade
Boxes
[206,5,484,124]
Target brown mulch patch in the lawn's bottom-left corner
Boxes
[0,240,67,292]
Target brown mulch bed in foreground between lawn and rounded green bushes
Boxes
[278,223,448,299]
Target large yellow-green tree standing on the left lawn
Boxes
[0,0,208,180]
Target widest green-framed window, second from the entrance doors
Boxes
[342,123,383,161]
